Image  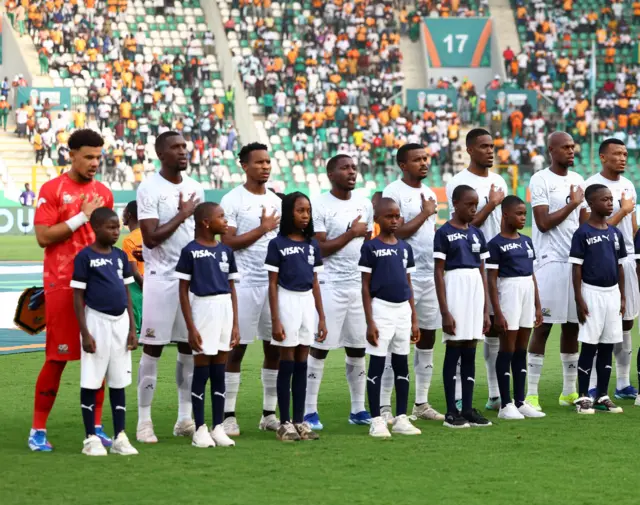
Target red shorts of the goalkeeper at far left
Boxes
[44,288,81,361]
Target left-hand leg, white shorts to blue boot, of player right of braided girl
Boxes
[304,284,348,431]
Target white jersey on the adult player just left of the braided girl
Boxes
[220,185,282,286]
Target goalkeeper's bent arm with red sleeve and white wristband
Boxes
[34,195,104,248]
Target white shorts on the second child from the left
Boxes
[191,294,233,356]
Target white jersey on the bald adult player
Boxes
[529,168,584,268]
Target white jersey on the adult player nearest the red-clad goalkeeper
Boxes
[136,172,204,276]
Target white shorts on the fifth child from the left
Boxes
[442,268,484,342]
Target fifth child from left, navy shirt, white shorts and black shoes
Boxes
[433,184,491,428]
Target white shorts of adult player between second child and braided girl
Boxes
[236,283,271,344]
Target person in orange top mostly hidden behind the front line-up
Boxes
[122,200,144,335]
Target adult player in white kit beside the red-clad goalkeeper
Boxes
[136,131,204,444]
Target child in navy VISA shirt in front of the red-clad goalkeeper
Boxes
[70,207,138,456]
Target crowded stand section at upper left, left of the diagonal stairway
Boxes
[12,0,238,190]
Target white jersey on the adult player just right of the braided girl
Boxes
[312,193,373,283]
